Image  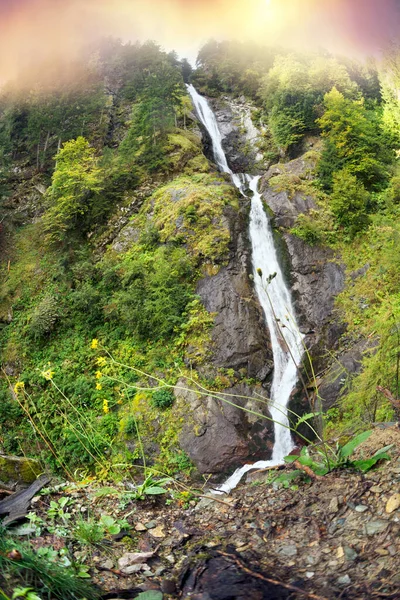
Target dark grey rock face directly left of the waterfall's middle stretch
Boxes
[196,206,273,381]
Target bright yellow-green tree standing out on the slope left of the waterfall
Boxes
[43,137,103,243]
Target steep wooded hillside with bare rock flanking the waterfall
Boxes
[0,40,400,598]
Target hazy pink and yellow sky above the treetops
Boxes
[0,0,400,80]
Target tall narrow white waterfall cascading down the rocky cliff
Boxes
[187,85,303,493]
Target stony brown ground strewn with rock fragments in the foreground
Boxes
[0,428,400,600]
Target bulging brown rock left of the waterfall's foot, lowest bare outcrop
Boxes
[174,380,273,473]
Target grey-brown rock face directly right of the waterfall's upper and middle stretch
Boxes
[261,156,345,369]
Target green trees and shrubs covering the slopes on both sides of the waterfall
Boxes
[0,34,400,502]
